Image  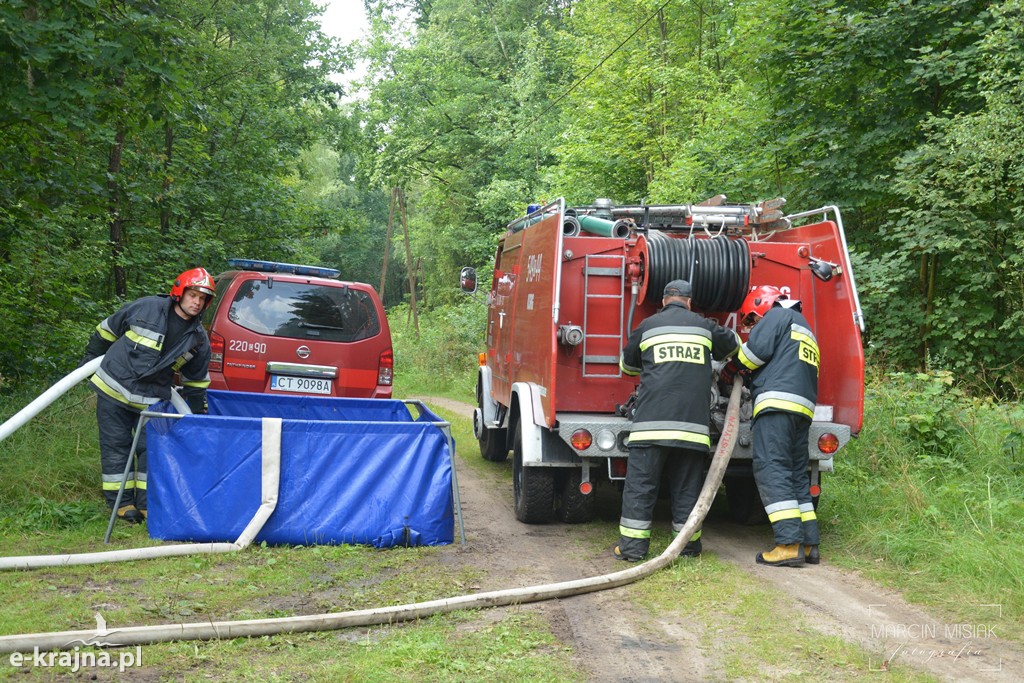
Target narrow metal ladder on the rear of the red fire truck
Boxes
[583,254,626,377]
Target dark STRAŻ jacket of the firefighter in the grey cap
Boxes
[618,302,739,453]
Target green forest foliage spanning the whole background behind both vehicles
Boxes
[0,0,1024,396]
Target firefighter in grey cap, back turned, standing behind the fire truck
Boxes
[612,280,739,562]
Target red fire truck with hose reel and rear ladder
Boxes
[462,196,864,523]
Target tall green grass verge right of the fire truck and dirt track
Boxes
[818,373,1024,642]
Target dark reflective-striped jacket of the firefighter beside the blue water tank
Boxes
[83,294,210,410]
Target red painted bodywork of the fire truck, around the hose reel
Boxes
[475,197,864,444]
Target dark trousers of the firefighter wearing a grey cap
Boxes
[618,444,705,558]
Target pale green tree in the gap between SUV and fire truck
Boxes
[362,0,562,304]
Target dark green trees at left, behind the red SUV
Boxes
[0,0,344,376]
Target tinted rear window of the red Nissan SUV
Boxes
[227,280,381,342]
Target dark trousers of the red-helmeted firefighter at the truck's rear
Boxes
[753,412,818,546]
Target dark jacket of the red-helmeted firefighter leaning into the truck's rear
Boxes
[737,303,820,420]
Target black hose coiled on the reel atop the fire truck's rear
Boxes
[647,230,751,312]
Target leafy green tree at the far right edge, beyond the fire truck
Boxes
[877,0,1024,390]
